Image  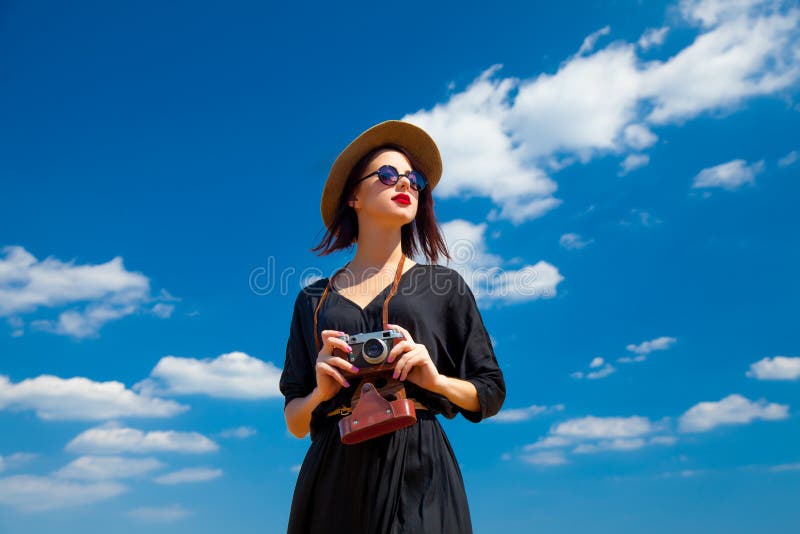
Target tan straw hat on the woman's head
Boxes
[320,121,442,228]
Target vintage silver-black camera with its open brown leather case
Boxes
[333,330,417,445]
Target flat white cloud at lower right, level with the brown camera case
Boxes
[679,394,789,432]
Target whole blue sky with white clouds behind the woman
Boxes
[0,0,800,534]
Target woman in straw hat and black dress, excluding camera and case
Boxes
[280,121,505,534]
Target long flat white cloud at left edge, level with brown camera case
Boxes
[0,375,189,421]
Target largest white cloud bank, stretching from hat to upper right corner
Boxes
[403,0,800,224]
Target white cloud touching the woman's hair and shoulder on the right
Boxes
[440,219,564,305]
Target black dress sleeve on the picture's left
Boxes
[279,291,316,407]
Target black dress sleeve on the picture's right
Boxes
[448,273,506,423]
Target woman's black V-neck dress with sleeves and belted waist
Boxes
[280,263,505,534]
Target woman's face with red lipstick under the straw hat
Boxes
[349,149,419,227]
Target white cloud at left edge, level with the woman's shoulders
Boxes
[0,246,176,338]
